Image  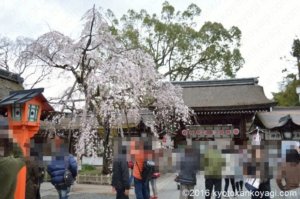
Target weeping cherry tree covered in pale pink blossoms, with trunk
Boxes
[18,7,189,174]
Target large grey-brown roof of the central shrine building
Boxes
[172,78,275,111]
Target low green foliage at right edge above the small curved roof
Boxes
[272,79,300,106]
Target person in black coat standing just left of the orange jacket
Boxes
[111,147,130,199]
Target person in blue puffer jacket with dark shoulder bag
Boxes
[47,137,77,199]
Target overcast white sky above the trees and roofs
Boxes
[0,0,300,98]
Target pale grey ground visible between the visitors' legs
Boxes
[41,173,300,199]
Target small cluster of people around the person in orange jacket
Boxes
[112,139,160,199]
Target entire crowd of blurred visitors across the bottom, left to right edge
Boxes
[0,131,300,199]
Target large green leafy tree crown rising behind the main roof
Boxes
[108,2,244,80]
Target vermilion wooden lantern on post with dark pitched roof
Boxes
[0,88,54,199]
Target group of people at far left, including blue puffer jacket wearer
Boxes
[0,130,77,199]
